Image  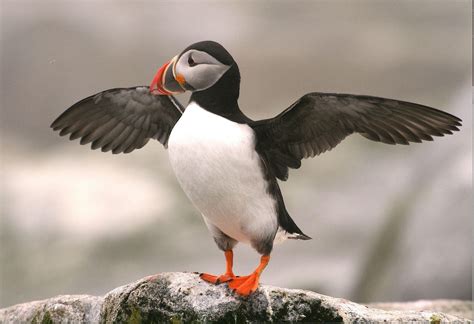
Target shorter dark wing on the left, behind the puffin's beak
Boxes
[51,86,184,154]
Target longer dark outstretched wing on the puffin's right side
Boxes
[252,92,461,180]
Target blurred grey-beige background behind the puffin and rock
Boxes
[0,0,472,307]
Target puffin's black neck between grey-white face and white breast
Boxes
[190,65,245,122]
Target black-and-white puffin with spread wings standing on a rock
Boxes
[51,41,462,296]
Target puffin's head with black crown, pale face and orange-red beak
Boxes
[150,41,236,95]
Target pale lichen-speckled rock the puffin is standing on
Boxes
[0,273,472,323]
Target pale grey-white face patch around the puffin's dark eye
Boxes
[175,50,230,91]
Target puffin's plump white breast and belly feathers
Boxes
[168,103,278,242]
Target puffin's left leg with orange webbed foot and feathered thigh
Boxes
[199,223,237,284]
